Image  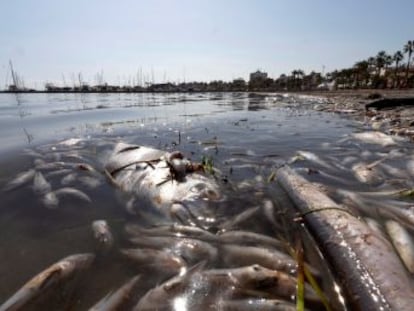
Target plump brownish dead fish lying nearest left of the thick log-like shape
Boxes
[220,244,296,274]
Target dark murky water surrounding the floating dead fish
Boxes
[0,93,414,310]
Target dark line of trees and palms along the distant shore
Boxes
[4,40,414,92]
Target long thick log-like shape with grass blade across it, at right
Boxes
[277,166,414,311]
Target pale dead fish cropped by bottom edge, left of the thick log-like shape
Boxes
[209,298,300,311]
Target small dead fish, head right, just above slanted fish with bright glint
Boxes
[121,248,187,276]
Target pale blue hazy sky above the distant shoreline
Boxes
[0,0,414,89]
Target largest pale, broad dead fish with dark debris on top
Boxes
[105,143,222,222]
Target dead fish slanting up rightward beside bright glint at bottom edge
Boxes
[133,262,205,311]
